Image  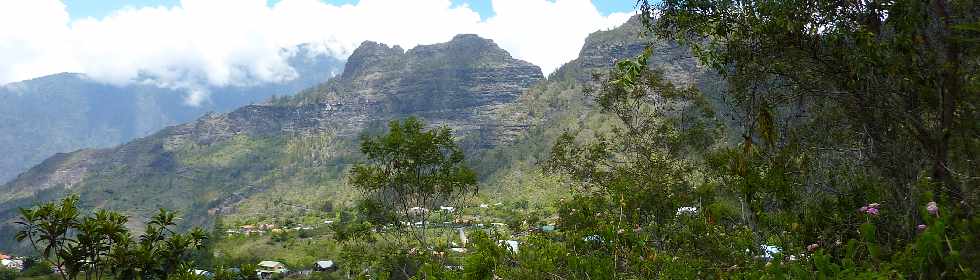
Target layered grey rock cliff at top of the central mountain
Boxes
[290,34,544,144]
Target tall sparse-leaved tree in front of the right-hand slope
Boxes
[546,48,731,279]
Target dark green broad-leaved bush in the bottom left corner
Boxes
[16,195,207,280]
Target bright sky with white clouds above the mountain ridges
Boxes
[0,0,634,103]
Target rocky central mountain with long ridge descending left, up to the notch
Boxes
[0,35,543,252]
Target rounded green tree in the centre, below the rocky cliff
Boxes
[350,118,477,248]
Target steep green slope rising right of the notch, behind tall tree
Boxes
[470,17,726,195]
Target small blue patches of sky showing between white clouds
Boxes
[64,0,635,20]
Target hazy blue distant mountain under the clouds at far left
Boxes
[0,45,343,182]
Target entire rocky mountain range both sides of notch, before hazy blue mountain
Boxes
[0,18,719,254]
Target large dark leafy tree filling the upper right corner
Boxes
[640,0,980,210]
